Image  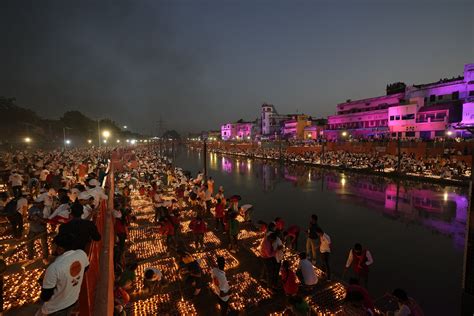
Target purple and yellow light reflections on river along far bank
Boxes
[209,153,468,250]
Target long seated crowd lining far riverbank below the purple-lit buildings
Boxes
[208,147,471,180]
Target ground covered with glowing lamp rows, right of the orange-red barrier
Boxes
[128,195,345,315]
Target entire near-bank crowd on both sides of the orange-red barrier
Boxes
[0,146,422,316]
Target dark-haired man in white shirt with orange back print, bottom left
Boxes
[37,234,89,316]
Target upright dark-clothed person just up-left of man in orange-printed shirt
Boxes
[27,195,49,264]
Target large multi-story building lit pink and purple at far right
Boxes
[325,64,474,139]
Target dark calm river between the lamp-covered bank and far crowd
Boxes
[173,148,468,315]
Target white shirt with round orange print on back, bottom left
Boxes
[41,250,89,314]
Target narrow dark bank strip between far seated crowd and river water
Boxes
[209,149,470,187]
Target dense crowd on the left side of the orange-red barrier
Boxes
[0,149,108,315]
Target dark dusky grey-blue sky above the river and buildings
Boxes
[0,0,474,133]
